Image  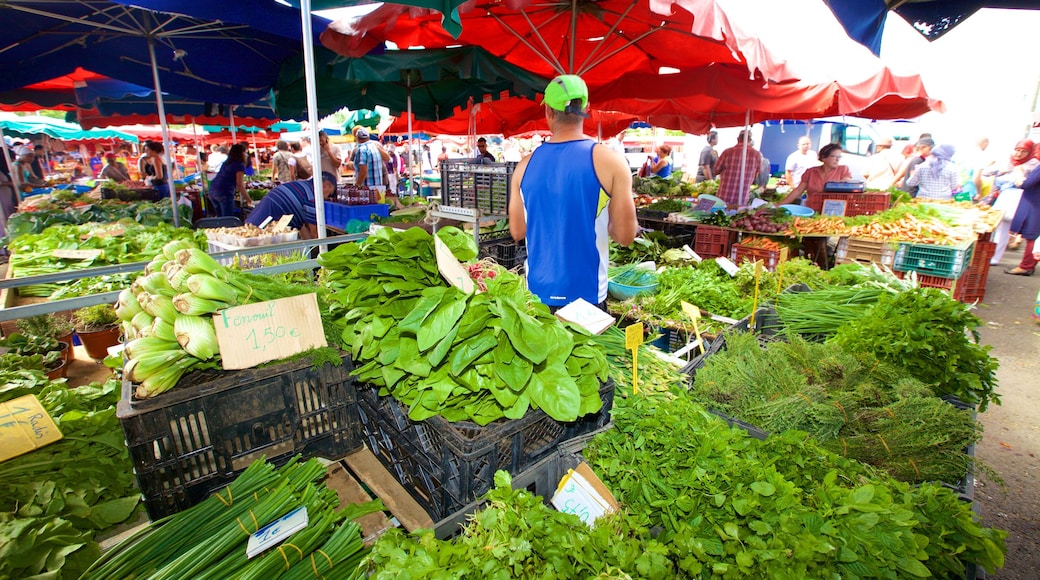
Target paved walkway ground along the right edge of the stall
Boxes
[976,249,1040,580]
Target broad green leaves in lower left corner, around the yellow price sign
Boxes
[0,380,140,578]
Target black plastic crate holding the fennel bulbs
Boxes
[116,355,362,520]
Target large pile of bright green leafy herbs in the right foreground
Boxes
[584,396,1007,578]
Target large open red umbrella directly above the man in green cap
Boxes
[321,0,791,85]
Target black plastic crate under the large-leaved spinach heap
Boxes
[358,385,614,521]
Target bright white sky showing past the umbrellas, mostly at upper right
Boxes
[319,0,1040,159]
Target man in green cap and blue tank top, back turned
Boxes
[510,75,639,309]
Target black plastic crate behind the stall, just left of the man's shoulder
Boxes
[441,161,517,215]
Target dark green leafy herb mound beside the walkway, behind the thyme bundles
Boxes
[831,288,1000,412]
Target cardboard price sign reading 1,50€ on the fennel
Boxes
[213,293,329,370]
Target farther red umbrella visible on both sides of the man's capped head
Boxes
[384,97,639,137]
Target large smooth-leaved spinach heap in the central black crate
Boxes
[321,228,607,425]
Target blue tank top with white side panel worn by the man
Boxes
[520,139,609,306]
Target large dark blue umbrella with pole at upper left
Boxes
[0,0,328,223]
